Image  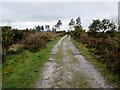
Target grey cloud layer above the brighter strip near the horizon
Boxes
[2,2,117,26]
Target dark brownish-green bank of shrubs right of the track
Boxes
[71,25,120,80]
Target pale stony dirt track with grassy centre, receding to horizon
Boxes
[36,36,109,88]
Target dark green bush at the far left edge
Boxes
[2,26,25,52]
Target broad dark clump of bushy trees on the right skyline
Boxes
[89,19,116,37]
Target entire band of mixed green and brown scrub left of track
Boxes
[2,26,65,53]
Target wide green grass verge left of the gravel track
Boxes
[2,37,60,88]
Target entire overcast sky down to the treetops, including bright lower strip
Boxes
[0,0,118,29]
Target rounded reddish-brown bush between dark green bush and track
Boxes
[24,32,57,51]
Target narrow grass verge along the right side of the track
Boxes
[71,38,120,88]
